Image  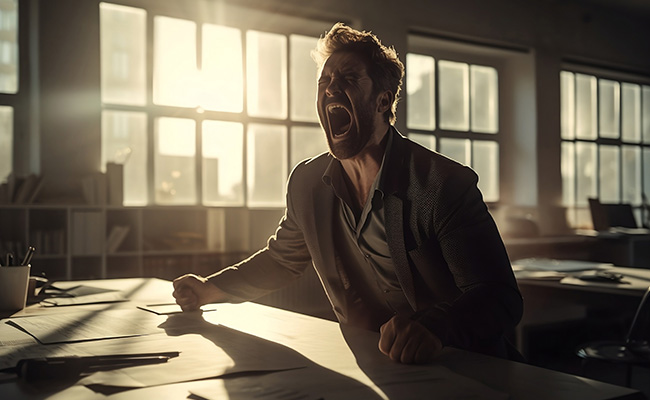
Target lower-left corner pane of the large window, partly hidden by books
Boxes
[102,111,149,206]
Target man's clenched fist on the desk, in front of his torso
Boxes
[379,315,442,364]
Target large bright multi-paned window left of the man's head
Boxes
[100,3,329,207]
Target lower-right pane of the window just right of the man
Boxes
[472,140,499,201]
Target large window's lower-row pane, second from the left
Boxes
[154,117,196,204]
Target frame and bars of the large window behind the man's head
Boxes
[98,0,333,209]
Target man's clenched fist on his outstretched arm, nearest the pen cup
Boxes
[172,274,227,311]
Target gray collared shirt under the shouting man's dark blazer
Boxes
[323,135,413,330]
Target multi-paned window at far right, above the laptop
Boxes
[560,70,650,228]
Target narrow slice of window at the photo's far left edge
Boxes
[0,0,18,182]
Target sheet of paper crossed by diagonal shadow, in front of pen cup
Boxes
[7,309,164,344]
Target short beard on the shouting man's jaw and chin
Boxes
[325,101,375,160]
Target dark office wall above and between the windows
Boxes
[21,0,650,212]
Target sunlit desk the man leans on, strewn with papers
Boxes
[0,279,643,400]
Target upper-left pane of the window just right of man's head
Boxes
[406,53,436,131]
